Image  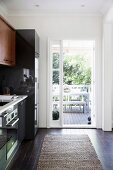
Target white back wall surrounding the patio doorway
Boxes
[8,15,102,127]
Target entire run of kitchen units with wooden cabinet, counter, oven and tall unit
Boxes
[0,17,39,170]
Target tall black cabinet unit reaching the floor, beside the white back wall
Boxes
[15,29,39,140]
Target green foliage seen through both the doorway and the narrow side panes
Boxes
[53,53,91,85]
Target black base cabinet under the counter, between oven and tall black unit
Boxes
[18,100,26,143]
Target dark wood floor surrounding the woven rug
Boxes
[10,129,113,170]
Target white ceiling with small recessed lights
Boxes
[0,0,113,15]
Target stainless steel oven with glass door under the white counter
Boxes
[0,105,19,160]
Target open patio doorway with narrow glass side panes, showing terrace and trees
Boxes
[48,40,95,127]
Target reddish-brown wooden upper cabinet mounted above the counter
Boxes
[0,18,16,66]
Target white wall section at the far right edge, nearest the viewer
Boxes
[102,6,113,131]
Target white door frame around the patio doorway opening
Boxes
[47,38,102,128]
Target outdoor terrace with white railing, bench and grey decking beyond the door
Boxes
[53,85,91,125]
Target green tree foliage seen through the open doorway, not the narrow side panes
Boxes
[63,56,91,84]
